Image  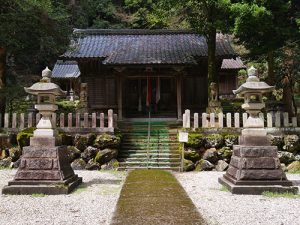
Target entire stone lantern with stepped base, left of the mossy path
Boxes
[2,68,82,195]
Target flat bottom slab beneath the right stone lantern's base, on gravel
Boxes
[219,177,298,195]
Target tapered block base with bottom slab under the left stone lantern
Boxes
[2,146,82,195]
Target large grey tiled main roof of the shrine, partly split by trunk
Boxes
[63,29,235,65]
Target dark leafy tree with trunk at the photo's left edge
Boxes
[0,0,70,113]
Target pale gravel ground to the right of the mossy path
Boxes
[175,172,300,225]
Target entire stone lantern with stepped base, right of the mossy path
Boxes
[219,67,298,194]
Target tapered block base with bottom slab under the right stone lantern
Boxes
[219,145,298,194]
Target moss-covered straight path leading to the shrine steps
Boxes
[111,170,205,225]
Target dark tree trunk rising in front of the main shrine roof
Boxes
[207,28,219,100]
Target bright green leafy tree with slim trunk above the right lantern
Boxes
[232,0,297,85]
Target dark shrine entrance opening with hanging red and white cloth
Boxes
[123,77,177,118]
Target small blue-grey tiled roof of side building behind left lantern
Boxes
[52,60,80,78]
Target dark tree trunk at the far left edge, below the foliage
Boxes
[0,47,6,119]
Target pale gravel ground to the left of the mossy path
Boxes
[0,170,126,225]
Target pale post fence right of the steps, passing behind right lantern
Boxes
[182,109,298,129]
